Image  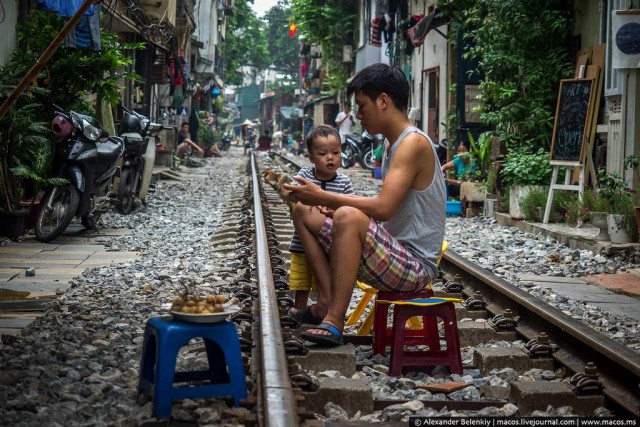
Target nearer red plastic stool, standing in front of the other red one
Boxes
[389,302,462,377]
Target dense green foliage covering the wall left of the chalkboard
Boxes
[441,0,573,148]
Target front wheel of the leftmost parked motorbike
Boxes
[35,185,80,243]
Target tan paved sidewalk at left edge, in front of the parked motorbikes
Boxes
[0,225,136,340]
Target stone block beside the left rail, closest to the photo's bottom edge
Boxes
[301,378,373,417]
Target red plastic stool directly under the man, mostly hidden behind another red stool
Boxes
[372,288,439,355]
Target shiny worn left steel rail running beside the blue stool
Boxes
[251,152,298,427]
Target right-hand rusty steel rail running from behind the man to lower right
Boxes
[442,250,640,417]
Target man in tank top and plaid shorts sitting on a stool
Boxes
[285,64,446,346]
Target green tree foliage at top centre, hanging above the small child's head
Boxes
[292,0,358,92]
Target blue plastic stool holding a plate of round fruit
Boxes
[138,316,247,418]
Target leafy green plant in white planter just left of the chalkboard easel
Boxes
[500,147,551,219]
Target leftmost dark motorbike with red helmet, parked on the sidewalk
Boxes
[35,105,124,242]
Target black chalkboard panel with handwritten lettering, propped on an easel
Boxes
[551,79,594,164]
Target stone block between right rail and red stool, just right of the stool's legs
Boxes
[473,348,554,375]
